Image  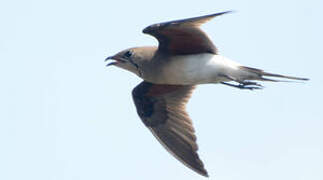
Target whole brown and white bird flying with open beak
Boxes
[106,11,308,177]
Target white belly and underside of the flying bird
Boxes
[155,53,252,85]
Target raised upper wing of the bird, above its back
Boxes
[143,11,231,55]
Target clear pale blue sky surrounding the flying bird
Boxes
[0,0,323,180]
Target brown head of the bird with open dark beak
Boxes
[105,47,157,76]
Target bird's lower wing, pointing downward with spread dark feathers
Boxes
[132,81,208,176]
